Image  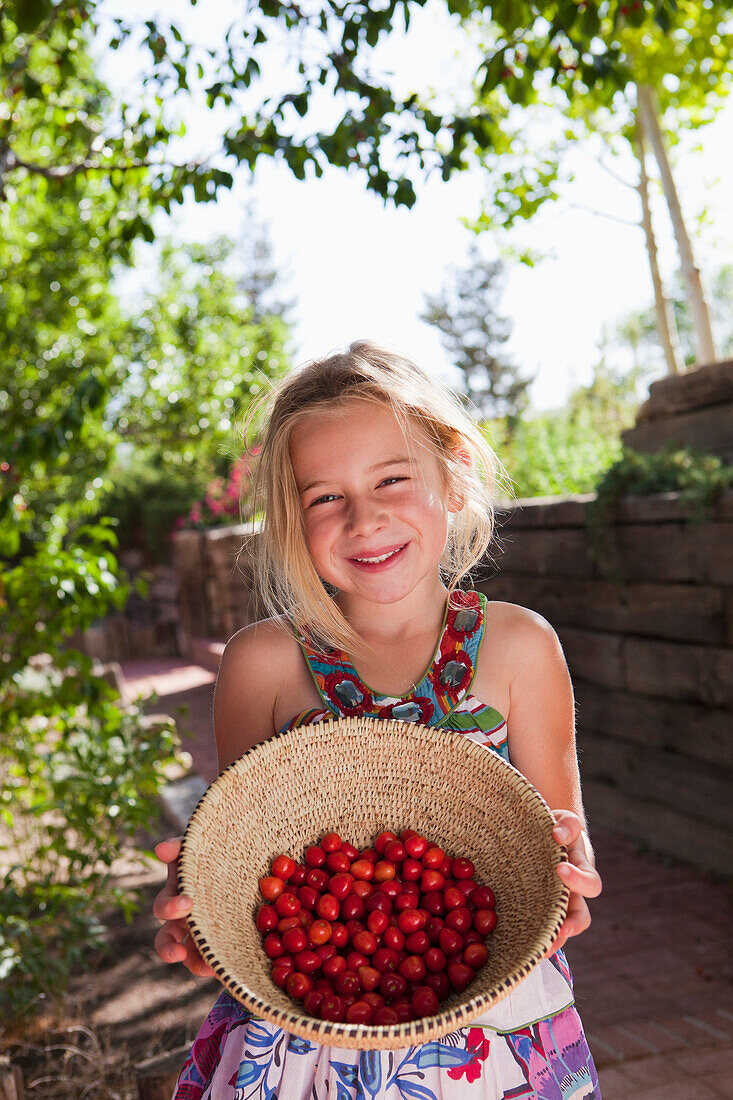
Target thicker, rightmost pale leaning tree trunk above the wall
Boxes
[636,85,715,364]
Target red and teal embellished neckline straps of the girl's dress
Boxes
[300,591,486,726]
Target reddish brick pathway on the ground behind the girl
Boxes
[122,659,733,1100]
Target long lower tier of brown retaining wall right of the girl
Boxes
[480,492,733,875]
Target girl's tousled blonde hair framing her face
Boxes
[239,341,501,653]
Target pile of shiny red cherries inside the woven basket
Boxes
[256,829,496,1025]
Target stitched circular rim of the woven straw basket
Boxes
[177,716,570,1049]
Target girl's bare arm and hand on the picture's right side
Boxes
[506,607,602,950]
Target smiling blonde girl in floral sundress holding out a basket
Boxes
[154,343,601,1100]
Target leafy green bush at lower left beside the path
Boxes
[0,655,177,1019]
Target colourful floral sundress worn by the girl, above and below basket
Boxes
[172,592,601,1100]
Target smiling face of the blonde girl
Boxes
[291,399,458,603]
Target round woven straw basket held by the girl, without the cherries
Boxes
[178,718,568,1049]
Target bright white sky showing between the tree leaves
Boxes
[94,0,733,408]
